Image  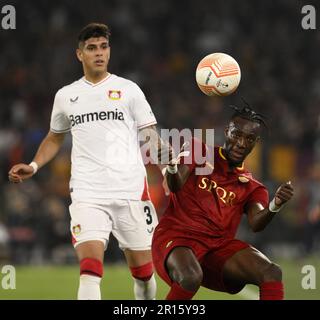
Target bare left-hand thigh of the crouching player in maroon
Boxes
[165,247,202,282]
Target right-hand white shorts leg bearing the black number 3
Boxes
[109,200,158,251]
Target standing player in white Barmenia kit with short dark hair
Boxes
[9,23,164,299]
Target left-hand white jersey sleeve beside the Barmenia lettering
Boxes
[50,91,71,133]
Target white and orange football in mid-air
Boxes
[196,52,241,96]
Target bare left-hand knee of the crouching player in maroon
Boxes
[174,267,203,291]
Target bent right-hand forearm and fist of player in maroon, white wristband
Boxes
[247,181,294,232]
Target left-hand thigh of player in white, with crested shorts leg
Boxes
[69,202,112,257]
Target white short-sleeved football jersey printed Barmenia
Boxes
[50,74,157,202]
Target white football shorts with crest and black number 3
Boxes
[69,200,158,250]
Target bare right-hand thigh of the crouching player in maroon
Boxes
[223,246,272,285]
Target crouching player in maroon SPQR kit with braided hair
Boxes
[152,107,293,300]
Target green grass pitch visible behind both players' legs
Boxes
[0,258,320,300]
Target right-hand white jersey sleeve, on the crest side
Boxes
[130,84,157,129]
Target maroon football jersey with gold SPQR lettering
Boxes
[158,139,269,238]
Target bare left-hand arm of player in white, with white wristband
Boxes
[9,131,65,183]
